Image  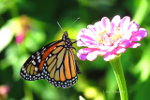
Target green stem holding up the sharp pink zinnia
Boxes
[110,56,128,100]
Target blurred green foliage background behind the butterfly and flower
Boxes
[0,0,150,100]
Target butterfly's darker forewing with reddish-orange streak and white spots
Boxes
[20,41,61,81]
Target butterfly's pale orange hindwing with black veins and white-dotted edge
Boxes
[46,47,79,88]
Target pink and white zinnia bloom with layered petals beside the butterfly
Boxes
[77,15,147,61]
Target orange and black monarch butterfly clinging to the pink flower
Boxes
[20,31,79,88]
